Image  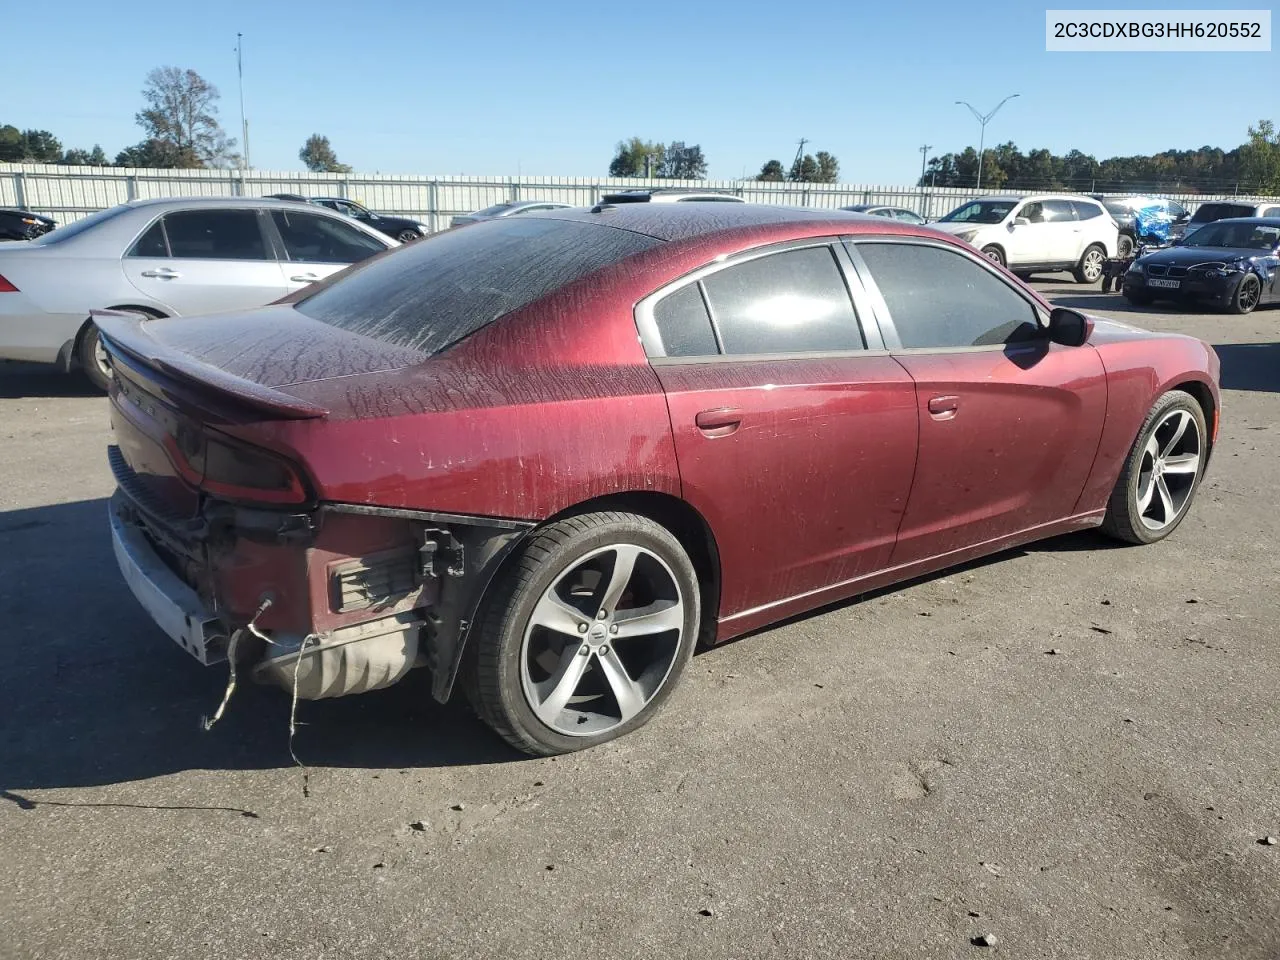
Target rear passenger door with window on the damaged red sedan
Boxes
[637,241,916,622]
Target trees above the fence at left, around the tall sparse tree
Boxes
[0,67,351,173]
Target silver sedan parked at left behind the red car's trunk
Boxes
[0,197,399,388]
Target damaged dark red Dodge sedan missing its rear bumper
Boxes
[97,204,1219,754]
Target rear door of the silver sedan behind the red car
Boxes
[123,209,285,315]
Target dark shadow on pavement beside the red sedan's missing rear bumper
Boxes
[0,499,524,805]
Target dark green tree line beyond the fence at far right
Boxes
[916,120,1280,195]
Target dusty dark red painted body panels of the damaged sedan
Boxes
[100,205,1219,650]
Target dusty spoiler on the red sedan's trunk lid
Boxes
[90,310,329,420]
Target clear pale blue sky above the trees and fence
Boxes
[0,0,1280,183]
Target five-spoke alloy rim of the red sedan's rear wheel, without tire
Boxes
[520,544,685,736]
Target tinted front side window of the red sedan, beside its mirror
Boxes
[858,242,1039,349]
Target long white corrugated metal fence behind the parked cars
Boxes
[0,164,1280,230]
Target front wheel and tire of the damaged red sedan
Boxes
[1102,390,1208,544]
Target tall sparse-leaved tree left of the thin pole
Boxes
[137,67,236,166]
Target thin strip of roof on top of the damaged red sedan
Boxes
[527,204,916,241]
